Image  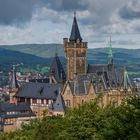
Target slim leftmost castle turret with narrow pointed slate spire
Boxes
[9,65,19,103]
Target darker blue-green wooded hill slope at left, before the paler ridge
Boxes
[0,48,51,68]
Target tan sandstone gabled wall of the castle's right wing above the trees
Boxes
[63,85,128,108]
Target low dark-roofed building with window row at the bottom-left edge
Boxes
[0,102,36,132]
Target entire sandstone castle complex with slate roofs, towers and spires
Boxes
[0,12,132,131]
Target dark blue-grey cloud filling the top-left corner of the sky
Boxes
[0,0,38,25]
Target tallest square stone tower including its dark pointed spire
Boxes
[63,13,87,81]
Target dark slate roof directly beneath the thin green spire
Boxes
[87,64,123,88]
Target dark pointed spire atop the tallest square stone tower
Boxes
[69,12,82,41]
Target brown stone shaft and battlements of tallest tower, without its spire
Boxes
[64,38,87,80]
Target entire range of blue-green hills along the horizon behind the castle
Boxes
[0,44,140,74]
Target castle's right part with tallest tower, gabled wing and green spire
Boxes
[62,15,132,108]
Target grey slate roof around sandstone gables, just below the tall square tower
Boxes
[69,73,105,96]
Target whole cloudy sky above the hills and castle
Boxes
[0,0,140,49]
